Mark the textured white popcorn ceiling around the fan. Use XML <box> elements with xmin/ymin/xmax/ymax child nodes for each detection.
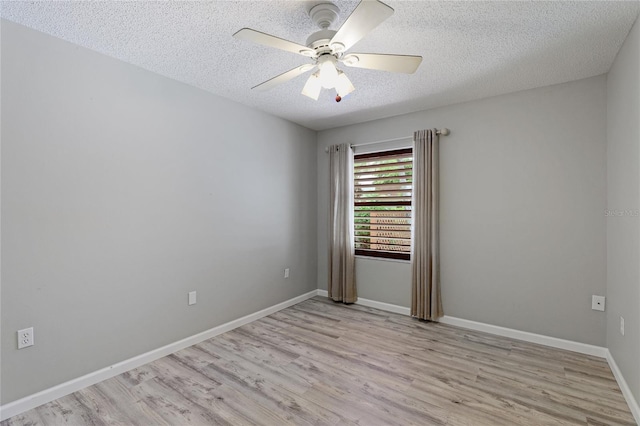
<box><xmin>0</xmin><ymin>0</ymin><xmax>640</xmax><ymax>130</ymax></box>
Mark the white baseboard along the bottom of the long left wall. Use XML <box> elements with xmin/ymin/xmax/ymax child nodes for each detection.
<box><xmin>0</xmin><ymin>290</ymin><xmax>317</xmax><ymax>421</ymax></box>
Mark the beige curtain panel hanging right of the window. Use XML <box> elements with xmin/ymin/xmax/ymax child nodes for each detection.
<box><xmin>411</xmin><ymin>129</ymin><xmax>443</xmax><ymax>321</ymax></box>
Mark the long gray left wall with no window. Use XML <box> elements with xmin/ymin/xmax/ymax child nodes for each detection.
<box><xmin>1</xmin><ymin>21</ymin><xmax>317</xmax><ymax>403</ymax></box>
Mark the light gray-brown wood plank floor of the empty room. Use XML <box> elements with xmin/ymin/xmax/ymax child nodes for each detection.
<box><xmin>1</xmin><ymin>297</ymin><xmax>635</xmax><ymax>426</ymax></box>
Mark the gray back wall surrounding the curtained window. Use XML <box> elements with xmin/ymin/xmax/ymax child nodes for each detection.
<box><xmin>318</xmin><ymin>76</ymin><xmax>606</xmax><ymax>346</ymax></box>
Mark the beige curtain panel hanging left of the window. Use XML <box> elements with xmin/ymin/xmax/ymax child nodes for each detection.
<box><xmin>328</xmin><ymin>144</ymin><xmax>358</xmax><ymax>303</ymax></box>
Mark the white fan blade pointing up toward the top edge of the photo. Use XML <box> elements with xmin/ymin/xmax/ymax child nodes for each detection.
<box><xmin>329</xmin><ymin>0</ymin><xmax>393</xmax><ymax>52</ymax></box>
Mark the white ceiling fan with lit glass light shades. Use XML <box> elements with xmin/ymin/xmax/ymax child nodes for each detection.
<box><xmin>233</xmin><ymin>0</ymin><xmax>422</xmax><ymax>102</ymax></box>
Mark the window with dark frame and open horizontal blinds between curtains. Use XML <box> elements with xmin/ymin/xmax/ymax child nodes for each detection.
<box><xmin>353</xmin><ymin>148</ymin><xmax>413</xmax><ymax>260</ymax></box>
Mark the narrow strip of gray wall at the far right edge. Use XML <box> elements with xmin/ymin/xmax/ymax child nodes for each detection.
<box><xmin>606</xmin><ymin>16</ymin><xmax>640</xmax><ymax>410</ymax></box>
